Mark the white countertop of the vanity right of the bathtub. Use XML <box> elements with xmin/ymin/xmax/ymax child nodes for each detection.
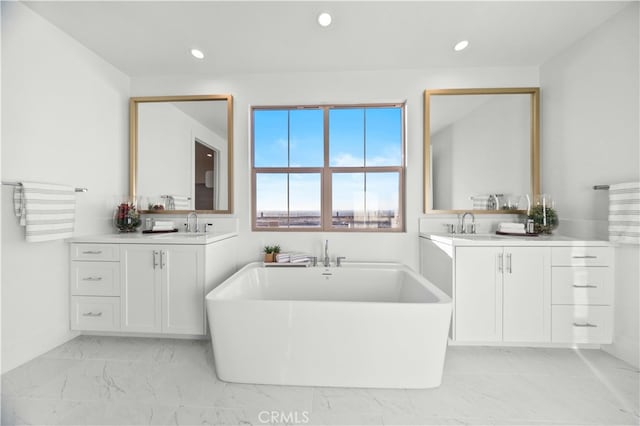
<box><xmin>420</xmin><ymin>232</ymin><xmax>611</xmax><ymax>247</ymax></box>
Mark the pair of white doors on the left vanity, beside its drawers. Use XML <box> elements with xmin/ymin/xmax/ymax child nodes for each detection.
<box><xmin>120</xmin><ymin>244</ymin><xmax>205</xmax><ymax>334</ymax></box>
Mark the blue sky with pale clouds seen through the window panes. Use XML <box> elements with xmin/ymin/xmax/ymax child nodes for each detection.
<box><xmin>253</xmin><ymin>108</ymin><xmax>402</xmax><ymax>212</ymax></box>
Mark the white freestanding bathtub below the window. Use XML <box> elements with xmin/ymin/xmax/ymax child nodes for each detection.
<box><xmin>206</xmin><ymin>262</ymin><xmax>451</xmax><ymax>388</ymax></box>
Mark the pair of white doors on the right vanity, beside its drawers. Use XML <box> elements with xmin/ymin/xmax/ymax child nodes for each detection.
<box><xmin>453</xmin><ymin>246</ymin><xmax>551</xmax><ymax>342</ymax></box>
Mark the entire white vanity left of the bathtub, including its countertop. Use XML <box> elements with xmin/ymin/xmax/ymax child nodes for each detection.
<box><xmin>70</xmin><ymin>233</ymin><xmax>237</xmax><ymax>336</ymax></box>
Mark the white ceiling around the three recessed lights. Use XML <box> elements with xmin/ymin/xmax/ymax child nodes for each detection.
<box><xmin>26</xmin><ymin>0</ymin><xmax>630</xmax><ymax>77</ymax></box>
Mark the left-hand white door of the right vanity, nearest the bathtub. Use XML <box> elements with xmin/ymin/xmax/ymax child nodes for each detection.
<box><xmin>454</xmin><ymin>247</ymin><xmax>502</xmax><ymax>342</ymax></box>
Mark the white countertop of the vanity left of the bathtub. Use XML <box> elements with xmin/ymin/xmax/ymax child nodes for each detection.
<box><xmin>69</xmin><ymin>232</ymin><xmax>238</xmax><ymax>245</ymax></box>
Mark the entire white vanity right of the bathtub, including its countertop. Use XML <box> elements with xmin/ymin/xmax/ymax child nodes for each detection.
<box><xmin>420</xmin><ymin>233</ymin><xmax>614</xmax><ymax>346</ymax></box>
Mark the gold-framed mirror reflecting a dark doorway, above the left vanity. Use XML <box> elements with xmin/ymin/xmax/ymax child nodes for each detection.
<box><xmin>129</xmin><ymin>95</ymin><xmax>233</xmax><ymax>214</ymax></box>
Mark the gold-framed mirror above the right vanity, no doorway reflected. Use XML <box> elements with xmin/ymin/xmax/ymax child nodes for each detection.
<box><xmin>423</xmin><ymin>87</ymin><xmax>540</xmax><ymax>214</ymax></box>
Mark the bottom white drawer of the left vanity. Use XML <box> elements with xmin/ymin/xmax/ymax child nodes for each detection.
<box><xmin>71</xmin><ymin>296</ymin><xmax>120</xmax><ymax>331</ymax></box>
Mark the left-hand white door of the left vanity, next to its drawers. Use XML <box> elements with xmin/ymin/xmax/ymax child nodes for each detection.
<box><xmin>120</xmin><ymin>244</ymin><xmax>162</xmax><ymax>332</ymax></box>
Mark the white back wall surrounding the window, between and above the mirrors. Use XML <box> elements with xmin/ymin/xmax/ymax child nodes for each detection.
<box><xmin>131</xmin><ymin>67</ymin><xmax>539</xmax><ymax>270</ymax></box>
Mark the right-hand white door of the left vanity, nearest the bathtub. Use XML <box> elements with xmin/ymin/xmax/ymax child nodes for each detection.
<box><xmin>161</xmin><ymin>245</ymin><xmax>205</xmax><ymax>334</ymax></box>
